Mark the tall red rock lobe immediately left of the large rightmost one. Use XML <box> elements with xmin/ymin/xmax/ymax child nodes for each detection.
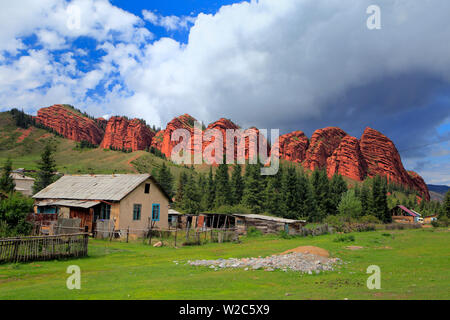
<box><xmin>327</xmin><ymin>136</ymin><xmax>367</xmax><ymax>181</ymax></box>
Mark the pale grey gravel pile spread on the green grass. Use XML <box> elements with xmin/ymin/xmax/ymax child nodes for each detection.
<box><xmin>187</xmin><ymin>253</ymin><xmax>342</xmax><ymax>274</ymax></box>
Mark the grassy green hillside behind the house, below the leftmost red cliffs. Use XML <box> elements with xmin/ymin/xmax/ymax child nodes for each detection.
<box><xmin>0</xmin><ymin>112</ymin><xmax>197</xmax><ymax>177</ymax></box>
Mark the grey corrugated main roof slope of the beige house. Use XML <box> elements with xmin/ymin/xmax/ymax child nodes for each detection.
<box><xmin>33</xmin><ymin>174</ymin><xmax>150</xmax><ymax>201</ymax></box>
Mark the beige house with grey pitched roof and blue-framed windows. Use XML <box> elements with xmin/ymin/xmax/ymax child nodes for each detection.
<box><xmin>33</xmin><ymin>174</ymin><xmax>169</xmax><ymax>235</ymax></box>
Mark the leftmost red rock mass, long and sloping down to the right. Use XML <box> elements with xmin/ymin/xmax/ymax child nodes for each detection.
<box><xmin>35</xmin><ymin>105</ymin><xmax>104</xmax><ymax>145</ymax></box>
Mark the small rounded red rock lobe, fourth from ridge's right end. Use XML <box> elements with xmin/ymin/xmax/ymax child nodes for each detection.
<box><xmin>279</xmin><ymin>131</ymin><xmax>309</xmax><ymax>163</ymax></box>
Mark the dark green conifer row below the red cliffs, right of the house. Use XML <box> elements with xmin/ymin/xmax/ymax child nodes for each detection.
<box><xmin>153</xmin><ymin>164</ymin><xmax>441</xmax><ymax>223</ymax></box>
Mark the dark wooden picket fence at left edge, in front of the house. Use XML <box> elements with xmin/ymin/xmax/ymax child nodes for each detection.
<box><xmin>0</xmin><ymin>233</ymin><xmax>89</xmax><ymax>263</ymax></box>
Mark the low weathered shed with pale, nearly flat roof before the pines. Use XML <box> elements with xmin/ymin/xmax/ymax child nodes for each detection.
<box><xmin>233</xmin><ymin>214</ymin><xmax>306</xmax><ymax>234</ymax></box>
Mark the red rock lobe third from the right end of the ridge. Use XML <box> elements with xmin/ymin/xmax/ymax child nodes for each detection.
<box><xmin>303</xmin><ymin>127</ymin><xmax>347</xmax><ymax>170</ymax></box>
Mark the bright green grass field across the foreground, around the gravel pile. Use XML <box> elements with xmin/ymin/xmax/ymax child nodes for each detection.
<box><xmin>0</xmin><ymin>229</ymin><xmax>450</xmax><ymax>300</ymax></box>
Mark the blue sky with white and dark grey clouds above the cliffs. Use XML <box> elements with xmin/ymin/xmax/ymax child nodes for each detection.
<box><xmin>0</xmin><ymin>0</ymin><xmax>450</xmax><ymax>184</ymax></box>
